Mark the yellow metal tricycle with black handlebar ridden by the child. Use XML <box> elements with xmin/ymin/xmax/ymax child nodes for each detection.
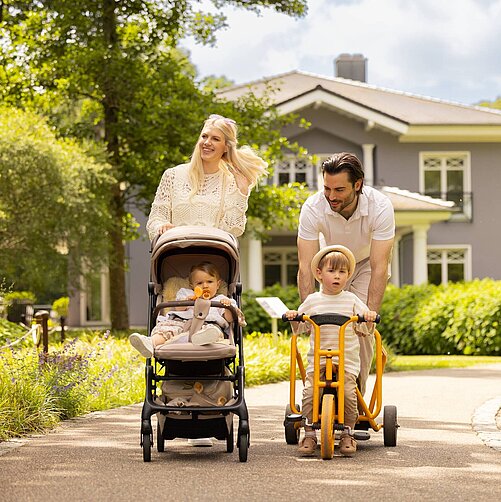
<box><xmin>282</xmin><ymin>314</ymin><xmax>399</xmax><ymax>459</ymax></box>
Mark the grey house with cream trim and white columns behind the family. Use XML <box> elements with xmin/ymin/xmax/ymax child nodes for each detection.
<box><xmin>68</xmin><ymin>55</ymin><xmax>501</xmax><ymax>325</ymax></box>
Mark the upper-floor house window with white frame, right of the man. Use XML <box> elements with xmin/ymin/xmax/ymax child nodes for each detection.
<box><xmin>420</xmin><ymin>152</ymin><xmax>472</xmax><ymax>221</ymax></box>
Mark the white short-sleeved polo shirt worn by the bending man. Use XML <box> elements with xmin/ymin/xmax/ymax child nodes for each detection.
<box><xmin>298</xmin><ymin>186</ymin><xmax>395</xmax><ymax>263</ymax></box>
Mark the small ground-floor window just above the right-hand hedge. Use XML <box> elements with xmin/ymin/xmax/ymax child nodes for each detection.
<box><xmin>428</xmin><ymin>246</ymin><xmax>471</xmax><ymax>285</ymax></box>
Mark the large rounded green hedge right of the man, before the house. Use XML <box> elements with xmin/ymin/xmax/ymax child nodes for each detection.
<box><xmin>380</xmin><ymin>279</ymin><xmax>501</xmax><ymax>355</ymax></box>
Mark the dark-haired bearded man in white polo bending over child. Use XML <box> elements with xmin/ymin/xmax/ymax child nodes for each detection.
<box><xmin>297</xmin><ymin>152</ymin><xmax>395</xmax><ymax>395</ymax></box>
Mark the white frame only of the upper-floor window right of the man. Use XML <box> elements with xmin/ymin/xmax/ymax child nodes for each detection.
<box><xmin>419</xmin><ymin>151</ymin><xmax>472</xmax><ymax>221</ymax></box>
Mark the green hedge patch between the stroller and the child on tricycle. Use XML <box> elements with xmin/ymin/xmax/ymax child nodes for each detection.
<box><xmin>242</xmin><ymin>284</ymin><xmax>301</xmax><ymax>334</ymax></box>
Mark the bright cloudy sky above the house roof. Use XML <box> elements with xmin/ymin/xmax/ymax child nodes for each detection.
<box><xmin>182</xmin><ymin>0</ymin><xmax>501</xmax><ymax>104</ymax></box>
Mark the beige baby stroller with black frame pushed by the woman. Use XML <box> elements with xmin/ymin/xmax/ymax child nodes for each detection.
<box><xmin>141</xmin><ymin>226</ymin><xmax>250</xmax><ymax>462</ymax></box>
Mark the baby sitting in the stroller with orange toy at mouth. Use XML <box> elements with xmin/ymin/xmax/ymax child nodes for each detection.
<box><xmin>129</xmin><ymin>261</ymin><xmax>244</xmax><ymax>357</ymax></box>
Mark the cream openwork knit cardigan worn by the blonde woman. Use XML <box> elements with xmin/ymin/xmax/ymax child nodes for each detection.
<box><xmin>146</xmin><ymin>164</ymin><xmax>249</xmax><ymax>240</ymax></box>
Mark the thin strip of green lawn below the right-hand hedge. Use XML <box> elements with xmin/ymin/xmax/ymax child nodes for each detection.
<box><xmin>389</xmin><ymin>355</ymin><xmax>501</xmax><ymax>371</ymax></box>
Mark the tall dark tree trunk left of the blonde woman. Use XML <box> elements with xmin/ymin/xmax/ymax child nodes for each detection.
<box><xmin>103</xmin><ymin>0</ymin><xmax>129</xmax><ymax>330</ymax></box>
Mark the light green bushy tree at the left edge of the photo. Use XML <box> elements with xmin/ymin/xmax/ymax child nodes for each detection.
<box><xmin>0</xmin><ymin>107</ymin><xmax>114</xmax><ymax>301</ymax></box>
